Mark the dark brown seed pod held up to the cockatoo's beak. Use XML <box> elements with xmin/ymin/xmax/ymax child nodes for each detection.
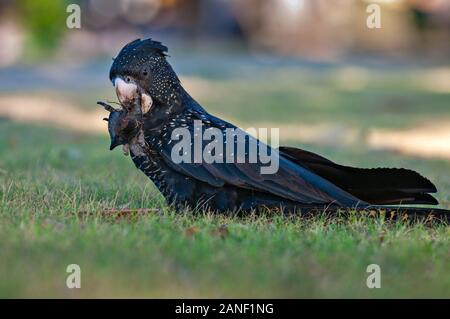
<box><xmin>97</xmin><ymin>102</ymin><xmax>141</xmax><ymax>150</ymax></box>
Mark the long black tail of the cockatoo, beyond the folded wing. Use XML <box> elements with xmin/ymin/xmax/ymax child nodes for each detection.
<box><xmin>279</xmin><ymin>146</ymin><xmax>438</xmax><ymax>206</ymax></box>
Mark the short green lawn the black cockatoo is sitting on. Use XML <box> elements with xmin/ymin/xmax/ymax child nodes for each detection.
<box><xmin>0</xmin><ymin>66</ymin><xmax>450</xmax><ymax>298</ymax></box>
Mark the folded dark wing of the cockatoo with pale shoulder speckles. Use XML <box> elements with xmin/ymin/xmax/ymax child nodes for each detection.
<box><xmin>147</xmin><ymin>109</ymin><xmax>365</xmax><ymax>206</ymax></box>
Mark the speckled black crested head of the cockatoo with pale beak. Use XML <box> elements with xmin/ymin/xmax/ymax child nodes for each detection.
<box><xmin>109</xmin><ymin>39</ymin><xmax>181</xmax><ymax>114</ymax></box>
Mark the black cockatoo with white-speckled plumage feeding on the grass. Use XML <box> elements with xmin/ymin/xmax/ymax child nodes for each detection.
<box><xmin>103</xmin><ymin>39</ymin><xmax>448</xmax><ymax>220</ymax></box>
